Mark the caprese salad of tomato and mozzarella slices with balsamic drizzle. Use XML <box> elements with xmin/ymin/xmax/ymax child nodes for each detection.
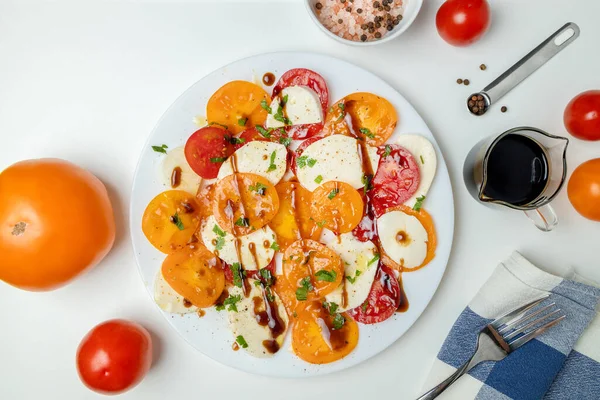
<box><xmin>142</xmin><ymin>69</ymin><xmax>436</xmax><ymax>364</ymax></box>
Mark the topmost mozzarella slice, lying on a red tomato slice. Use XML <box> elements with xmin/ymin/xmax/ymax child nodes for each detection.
<box><xmin>266</xmin><ymin>86</ymin><xmax>323</xmax><ymax>128</ymax></box>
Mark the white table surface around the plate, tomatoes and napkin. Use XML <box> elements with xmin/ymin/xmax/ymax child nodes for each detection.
<box><xmin>0</xmin><ymin>0</ymin><xmax>600</xmax><ymax>400</ymax></box>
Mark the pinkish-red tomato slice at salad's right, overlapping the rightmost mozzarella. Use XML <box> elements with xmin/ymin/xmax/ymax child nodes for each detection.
<box><xmin>369</xmin><ymin>144</ymin><xmax>420</xmax><ymax>217</ymax></box>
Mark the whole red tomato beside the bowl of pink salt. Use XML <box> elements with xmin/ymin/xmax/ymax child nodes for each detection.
<box><xmin>435</xmin><ymin>0</ymin><xmax>490</xmax><ymax>46</ymax></box>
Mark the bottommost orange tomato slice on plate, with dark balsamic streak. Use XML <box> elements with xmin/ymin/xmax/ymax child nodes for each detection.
<box><xmin>292</xmin><ymin>302</ymin><xmax>359</xmax><ymax>364</ymax></box>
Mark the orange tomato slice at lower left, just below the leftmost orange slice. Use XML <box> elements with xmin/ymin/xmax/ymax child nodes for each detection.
<box><xmin>161</xmin><ymin>244</ymin><xmax>225</xmax><ymax>308</ymax></box>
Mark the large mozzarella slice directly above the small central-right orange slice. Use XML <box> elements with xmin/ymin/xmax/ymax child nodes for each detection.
<box><xmin>296</xmin><ymin>135</ymin><xmax>364</xmax><ymax>192</ymax></box>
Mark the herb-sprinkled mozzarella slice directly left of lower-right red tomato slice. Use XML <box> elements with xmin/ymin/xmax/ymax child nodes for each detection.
<box><xmin>325</xmin><ymin>232</ymin><xmax>378</xmax><ymax>311</ymax></box>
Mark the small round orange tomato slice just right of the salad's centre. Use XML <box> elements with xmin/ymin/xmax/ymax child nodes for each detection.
<box><xmin>311</xmin><ymin>181</ymin><xmax>364</xmax><ymax>235</ymax></box>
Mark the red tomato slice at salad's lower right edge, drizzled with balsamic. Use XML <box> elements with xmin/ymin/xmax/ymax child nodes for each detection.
<box><xmin>348</xmin><ymin>263</ymin><xmax>401</xmax><ymax>324</ymax></box>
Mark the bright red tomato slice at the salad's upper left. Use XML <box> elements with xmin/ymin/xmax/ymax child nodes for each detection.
<box><xmin>185</xmin><ymin>126</ymin><xmax>235</xmax><ymax>179</ymax></box>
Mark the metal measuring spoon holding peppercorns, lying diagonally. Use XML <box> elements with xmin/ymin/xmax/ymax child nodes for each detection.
<box><xmin>467</xmin><ymin>22</ymin><xmax>580</xmax><ymax>115</ymax></box>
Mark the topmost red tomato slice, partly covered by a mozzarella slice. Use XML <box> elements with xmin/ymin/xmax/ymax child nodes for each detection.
<box><xmin>272</xmin><ymin>68</ymin><xmax>329</xmax><ymax>140</ymax></box>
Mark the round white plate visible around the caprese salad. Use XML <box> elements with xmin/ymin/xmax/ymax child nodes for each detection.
<box><xmin>130</xmin><ymin>52</ymin><xmax>454</xmax><ymax>377</ymax></box>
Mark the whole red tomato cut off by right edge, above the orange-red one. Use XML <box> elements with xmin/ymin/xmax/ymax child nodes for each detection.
<box><xmin>564</xmin><ymin>90</ymin><xmax>600</xmax><ymax>140</ymax></box>
